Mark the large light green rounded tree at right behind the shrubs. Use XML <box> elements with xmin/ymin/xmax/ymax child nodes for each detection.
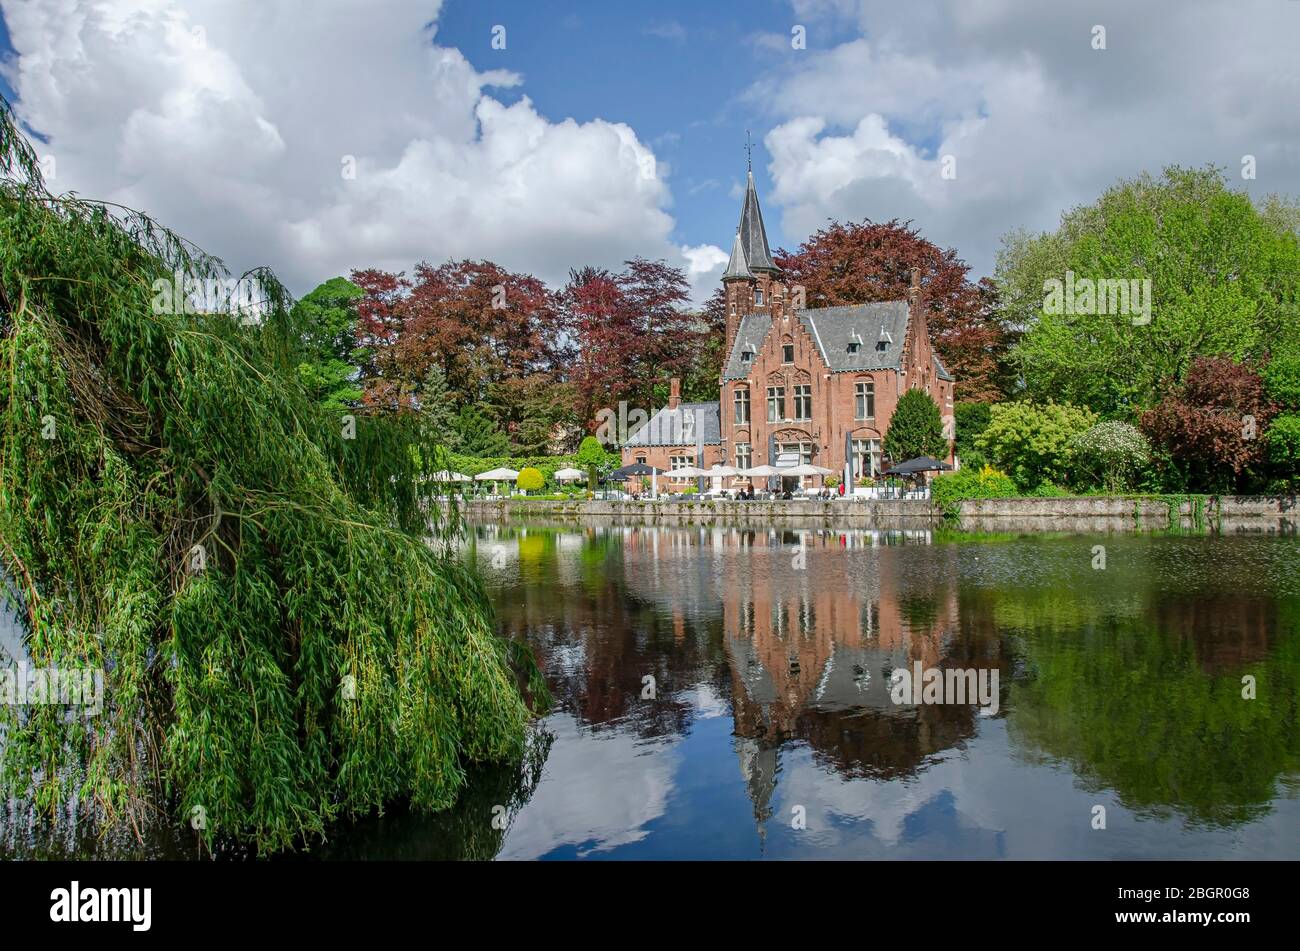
<box><xmin>996</xmin><ymin>168</ymin><xmax>1300</xmax><ymax>416</ymax></box>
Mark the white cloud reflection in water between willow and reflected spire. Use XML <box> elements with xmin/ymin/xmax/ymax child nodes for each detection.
<box><xmin>498</xmin><ymin>713</ymin><xmax>680</xmax><ymax>859</ymax></box>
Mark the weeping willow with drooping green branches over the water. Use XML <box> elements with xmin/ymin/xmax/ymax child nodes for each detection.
<box><xmin>0</xmin><ymin>99</ymin><xmax>536</xmax><ymax>854</ymax></box>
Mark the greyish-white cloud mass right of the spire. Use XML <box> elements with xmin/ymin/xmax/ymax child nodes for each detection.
<box><xmin>748</xmin><ymin>0</ymin><xmax>1300</xmax><ymax>273</ymax></box>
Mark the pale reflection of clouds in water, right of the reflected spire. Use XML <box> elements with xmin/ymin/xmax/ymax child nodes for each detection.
<box><xmin>767</xmin><ymin>720</ymin><xmax>1300</xmax><ymax>859</ymax></box>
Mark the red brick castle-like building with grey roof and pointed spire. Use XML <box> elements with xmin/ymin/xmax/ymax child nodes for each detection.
<box><xmin>623</xmin><ymin>164</ymin><xmax>953</xmax><ymax>487</ymax></box>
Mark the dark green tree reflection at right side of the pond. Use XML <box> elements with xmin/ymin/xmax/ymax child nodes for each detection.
<box><xmin>979</xmin><ymin>579</ymin><xmax>1300</xmax><ymax>825</ymax></box>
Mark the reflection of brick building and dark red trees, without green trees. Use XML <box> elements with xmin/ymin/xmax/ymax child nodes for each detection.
<box><xmin>483</xmin><ymin>526</ymin><xmax>1006</xmax><ymax>828</ymax></box>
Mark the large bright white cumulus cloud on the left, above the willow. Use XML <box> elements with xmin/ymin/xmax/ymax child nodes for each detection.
<box><xmin>0</xmin><ymin>0</ymin><xmax>720</xmax><ymax>292</ymax></box>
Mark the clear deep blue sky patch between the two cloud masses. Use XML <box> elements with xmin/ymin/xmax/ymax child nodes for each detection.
<box><xmin>428</xmin><ymin>0</ymin><xmax>853</xmax><ymax>255</ymax></box>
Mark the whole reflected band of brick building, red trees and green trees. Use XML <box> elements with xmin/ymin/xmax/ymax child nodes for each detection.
<box><xmin>480</xmin><ymin>527</ymin><xmax>1300</xmax><ymax>841</ymax></box>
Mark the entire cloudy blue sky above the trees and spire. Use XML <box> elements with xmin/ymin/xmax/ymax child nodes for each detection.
<box><xmin>0</xmin><ymin>0</ymin><xmax>1300</xmax><ymax>300</ymax></box>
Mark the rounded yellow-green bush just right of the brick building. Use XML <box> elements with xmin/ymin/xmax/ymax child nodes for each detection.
<box><xmin>975</xmin><ymin>403</ymin><xmax>1097</xmax><ymax>491</ymax></box>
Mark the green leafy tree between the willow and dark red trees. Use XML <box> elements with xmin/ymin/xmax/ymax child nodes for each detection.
<box><xmin>291</xmin><ymin>277</ymin><xmax>365</xmax><ymax>409</ymax></box>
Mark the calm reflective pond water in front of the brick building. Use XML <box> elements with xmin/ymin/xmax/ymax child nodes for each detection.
<box><xmin>0</xmin><ymin>525</ymin><xmax>1300</xmax><ymax>859</ymax></box>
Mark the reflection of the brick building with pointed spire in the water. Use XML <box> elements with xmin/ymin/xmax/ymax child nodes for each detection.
<box><xmin>719</xmin><ymin>531</ymin><xmax>1002</xmax><ymax>828</ymax></box>
